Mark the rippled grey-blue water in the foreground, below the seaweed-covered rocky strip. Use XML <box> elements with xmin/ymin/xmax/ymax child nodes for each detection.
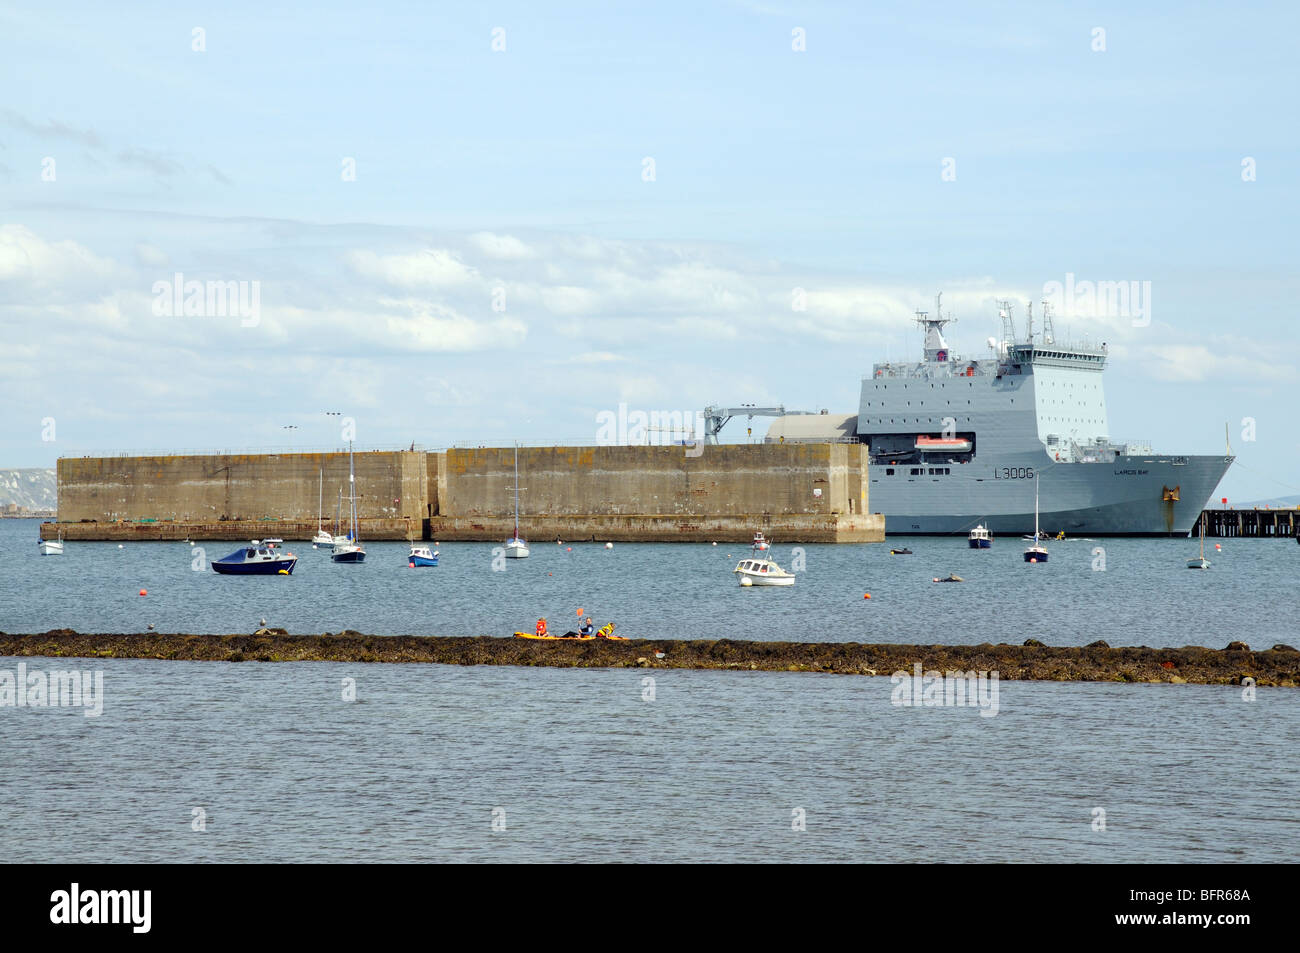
<box><xmin>0</xmin><ymin>658</ymin><xmax>1300</xmax><ymax>862</ymax></box>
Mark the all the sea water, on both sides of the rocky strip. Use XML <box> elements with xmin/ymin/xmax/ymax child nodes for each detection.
<box><xmin>0</xmin><ymin>520</ymin><xmax>1300</xmax><ymax>862</ymax></box>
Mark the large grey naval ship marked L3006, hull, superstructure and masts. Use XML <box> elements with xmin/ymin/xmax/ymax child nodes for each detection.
<box><xmin>857</xmin><ymin>302</ymin><xmax>1234</xmax><ymax>536</ymax></box>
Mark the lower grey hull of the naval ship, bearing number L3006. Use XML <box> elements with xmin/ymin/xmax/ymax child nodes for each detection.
<box><xmin>868</xmin><ymin>454</ymin><xmax>1232</xmax><ymax>537</ymax></box>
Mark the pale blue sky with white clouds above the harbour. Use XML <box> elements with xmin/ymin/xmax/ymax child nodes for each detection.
<box><xmin>0</xmin><ymin>1</ymin><xmax>1300</xmax><ymax>499</ymax></box>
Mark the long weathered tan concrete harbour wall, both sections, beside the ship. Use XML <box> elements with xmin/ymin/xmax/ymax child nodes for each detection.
<box><xmin>42</xmin><ymin>443</ymin><xmax>884</xmax><ymax>542</ymax></box>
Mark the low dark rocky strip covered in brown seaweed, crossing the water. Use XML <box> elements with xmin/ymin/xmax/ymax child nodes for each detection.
<box><xmin>0</xmin><ymin>629</ymin><xmax>1300</xmax><ymax>688</ymax></box>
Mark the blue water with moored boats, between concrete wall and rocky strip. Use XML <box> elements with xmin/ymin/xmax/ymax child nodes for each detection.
<box><xmin>0</xmin><ymin>520</ymin><xmax>1300</xmax><ymax>647</ymax></box>
